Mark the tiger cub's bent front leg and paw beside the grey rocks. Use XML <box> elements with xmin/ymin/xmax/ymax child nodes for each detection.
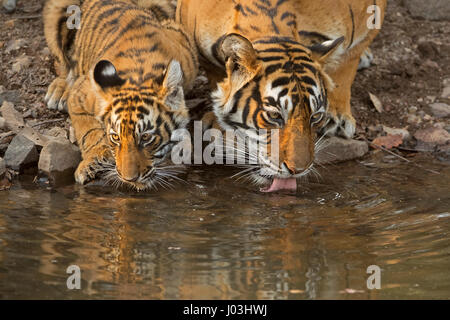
<box><xmin>68</xmin><ymin>79</ymin><xmax>114</xmax><ymax>185</ymax></box>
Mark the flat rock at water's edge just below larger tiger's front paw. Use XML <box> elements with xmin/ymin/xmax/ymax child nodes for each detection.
<box><xmin>317</xmin><ymin>137</ymin><xmax>369</xmax><ymax>163</ymax></box>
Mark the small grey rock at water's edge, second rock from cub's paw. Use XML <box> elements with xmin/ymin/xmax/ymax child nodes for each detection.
<box><xmin>4</xmin><ymin>134</ymin><xmax>39</xmax><ymax>171</ymax></box>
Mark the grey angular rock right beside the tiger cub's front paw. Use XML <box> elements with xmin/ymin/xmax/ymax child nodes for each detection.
<box><xmin>38</xmin><ymin>140</ymin><xmax>81</xmax><ymax>183</ymax></box>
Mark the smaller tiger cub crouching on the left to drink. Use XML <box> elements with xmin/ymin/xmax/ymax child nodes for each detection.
<box><xmin>44</xmin><ymin>0</ymin><xmax>198</xmax><ymax>190</ymax></box>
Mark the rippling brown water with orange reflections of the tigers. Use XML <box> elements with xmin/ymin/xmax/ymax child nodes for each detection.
<box><xmin>0</xmin><ymin>154</ymin><xmax>450</xmax><ymax>299</ymax></box>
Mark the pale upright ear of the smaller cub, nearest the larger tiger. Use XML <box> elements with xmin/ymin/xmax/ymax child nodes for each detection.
<box><xmin>163</xmin><ymin>60</ymin><xmax>186</xmax><ymax>110</ymax></box>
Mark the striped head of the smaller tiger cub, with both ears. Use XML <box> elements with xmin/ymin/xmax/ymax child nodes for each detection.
<box><xmin>92</xmin><ymin>60</ymin><xmax>189</xmax><ymax>190</ymax></box>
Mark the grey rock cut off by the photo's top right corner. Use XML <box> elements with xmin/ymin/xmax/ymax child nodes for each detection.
<box><xmin>404</xmin><ymin>0</ymin><xmax>450</xmax><ymax>20</ymax></box>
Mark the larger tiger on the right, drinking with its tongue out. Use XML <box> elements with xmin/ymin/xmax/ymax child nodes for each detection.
<box><xmin>177</xmin><ymin>0</ymin><xmax>386</xmax><ymax>191</ymax></box>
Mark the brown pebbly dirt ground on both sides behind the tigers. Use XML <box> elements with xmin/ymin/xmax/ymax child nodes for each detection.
<box><xmin>0</xmin><ymin>0</ymin><xmax>450</xmax><ymax>157</ymax></box>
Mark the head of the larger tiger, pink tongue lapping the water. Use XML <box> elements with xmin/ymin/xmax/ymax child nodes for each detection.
<box><xmin>213</xmin><ymin>34</ymin><xmax>344</xmax><ymax>192</ymax></box>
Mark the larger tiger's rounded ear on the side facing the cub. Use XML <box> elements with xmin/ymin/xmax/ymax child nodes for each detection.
<box><xmin>218</xmin><ymin>33</ymin><xmax>261</xmax><ymax>93</ymax></box>
